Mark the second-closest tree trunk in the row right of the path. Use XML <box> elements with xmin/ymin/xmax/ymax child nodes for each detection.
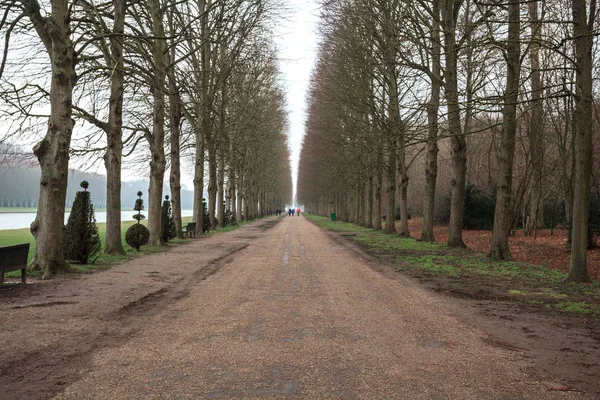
<box><xmin>490</xmin><ymin>0</ymin><xmax>521</xmax><ymax>260</ymax></box>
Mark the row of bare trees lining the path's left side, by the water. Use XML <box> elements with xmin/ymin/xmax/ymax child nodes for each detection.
<box><xmin>0</xmin><ymin>0</ymin><xmax>291</xmax><ymax>277</ymax></box>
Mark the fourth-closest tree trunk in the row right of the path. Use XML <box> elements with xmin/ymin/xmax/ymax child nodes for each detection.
<box><xmin>421</xmin><ymin>0</ymin><xmax>442</xmax><ymax>242</ymax></box>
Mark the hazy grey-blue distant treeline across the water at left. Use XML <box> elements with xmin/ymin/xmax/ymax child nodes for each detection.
<box><xmin>0</xmin><ymin>165</ymin><xmax>193</xmax><ymax>209</ymax></box>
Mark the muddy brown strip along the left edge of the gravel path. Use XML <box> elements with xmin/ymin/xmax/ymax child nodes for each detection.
<box><xmin>0</xmin><ymin>219</ymin><xmax>277</xmax><ymax>400</ymax></box>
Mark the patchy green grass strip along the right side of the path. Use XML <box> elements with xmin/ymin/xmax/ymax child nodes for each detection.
<box><xmin>305</xmin><ymin>214</ymin><xmax>600</xmax><ymax>317</ymax></box>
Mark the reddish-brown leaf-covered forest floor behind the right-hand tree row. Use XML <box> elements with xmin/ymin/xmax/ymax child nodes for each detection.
<box><xmin>408</xmin><ymin>218</ymin><xmax>600</xmax><ymax>281</ymax></box>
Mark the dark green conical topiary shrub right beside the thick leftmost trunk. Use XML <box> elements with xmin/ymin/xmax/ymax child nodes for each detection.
<box><xmin>63</xmin><ymin>181</ymin><xmax>102</xmax><ymax>264</ymax></box>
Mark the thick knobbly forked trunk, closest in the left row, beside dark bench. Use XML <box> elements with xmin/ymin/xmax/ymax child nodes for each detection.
<box><xmin>24</xmin><ymin>0</ymin><xmax>77</xmax><ymax>279</ymax></box>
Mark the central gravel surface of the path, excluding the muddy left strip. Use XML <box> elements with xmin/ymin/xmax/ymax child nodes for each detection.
<box><xmin>49</xmin><ymin>217</ymin><xmax>583</xmax><ymax>400</ymax></box>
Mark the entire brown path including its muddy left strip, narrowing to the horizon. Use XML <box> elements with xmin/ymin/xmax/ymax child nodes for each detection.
<box><xmin>0</xmin><ymin>217</ymin><xmax>598</xmax><ymax>399</ymax></box>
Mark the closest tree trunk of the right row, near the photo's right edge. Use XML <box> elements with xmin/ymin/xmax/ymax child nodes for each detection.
<box><xmin>568</xmin><ymin>0</ymin><xmax>596</xmax><ymax>282</ymax></box>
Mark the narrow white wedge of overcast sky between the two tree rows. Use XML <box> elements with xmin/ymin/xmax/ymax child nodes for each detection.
<box><xmin>275</xmin><ymin>0</ymin><xmax>319</xmax><ymax>200</ymax></box>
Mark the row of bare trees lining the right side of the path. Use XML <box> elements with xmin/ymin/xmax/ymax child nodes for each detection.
<box><xmin>298</xmin><ymin>0</ymin><xmax>598</xmax><ymax>281</ymax></box>
